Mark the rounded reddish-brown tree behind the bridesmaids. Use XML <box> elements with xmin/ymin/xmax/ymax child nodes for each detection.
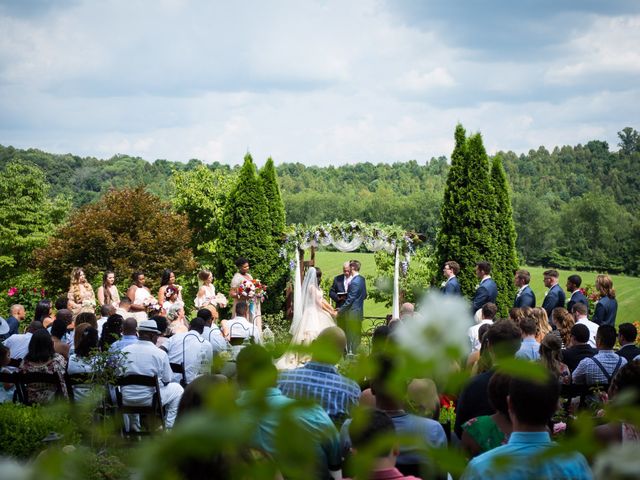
<box><xmin>35</xmin><ymin>187</ymin><xmax>196</xmax><ymax>291</ymax></box>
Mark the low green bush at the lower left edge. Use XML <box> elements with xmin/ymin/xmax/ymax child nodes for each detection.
<box><xmin>0</xmin><ymin>403</ymin><xmax>79</xmax><ymax>459</ymax></box>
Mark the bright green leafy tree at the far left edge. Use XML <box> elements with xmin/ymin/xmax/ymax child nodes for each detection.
<box><xmin>0</xmin><ymin>161</ymin><xmax>69</xmax><ymax>283</ymax></box>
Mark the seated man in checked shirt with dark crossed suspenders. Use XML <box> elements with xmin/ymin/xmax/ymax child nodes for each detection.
<box><xmin>572</xmin><ymin>324</ymin><xmax>627</xmax><ymax>385</ymax></box>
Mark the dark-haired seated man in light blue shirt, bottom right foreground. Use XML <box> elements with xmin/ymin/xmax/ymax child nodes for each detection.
<box><xmin>462</xmin><ymin>375</ymin><xmax>592</xmax><ymax>480</ymax></box>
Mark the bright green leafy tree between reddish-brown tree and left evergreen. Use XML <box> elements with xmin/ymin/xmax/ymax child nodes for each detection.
<box><xmin>172</xmin><ymin>165</ymin><xmax>234</xmax><ymax>266</ymax></box>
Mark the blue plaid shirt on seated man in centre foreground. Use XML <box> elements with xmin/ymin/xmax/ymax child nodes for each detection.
<box><xmin>278</xmin><ymin>362</ymin><xmax>360</xmax><ymax>422</ymax></box>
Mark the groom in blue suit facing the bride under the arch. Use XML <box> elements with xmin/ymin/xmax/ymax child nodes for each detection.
<box><xmin>338</xmin><ymin>260</ymin><xmax>367</xmax><ymax>354</ymax></box>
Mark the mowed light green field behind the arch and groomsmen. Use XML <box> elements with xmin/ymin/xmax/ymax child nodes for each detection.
<box><xmin>307</xmin><ymin>251</ymin><xmax>640</xmax><ymax>324</ymax></box>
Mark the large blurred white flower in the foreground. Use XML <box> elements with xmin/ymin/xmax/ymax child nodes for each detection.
<box><xmin>395</xmin><ymin>292</ymin><xmax>473</xmax><ymax>360</ymax></box>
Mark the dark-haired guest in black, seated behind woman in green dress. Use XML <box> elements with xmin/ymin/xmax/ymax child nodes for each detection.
<box><xmin>454</xmin><ymin>320</ymin><xmax>520</xmax><ymax>438</ymax></box>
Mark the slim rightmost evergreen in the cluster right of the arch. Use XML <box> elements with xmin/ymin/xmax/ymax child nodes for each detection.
<box><xmin>491</xmin><ymin>155</ymin><xmax>518</xmax><ymax>317</ymax></box>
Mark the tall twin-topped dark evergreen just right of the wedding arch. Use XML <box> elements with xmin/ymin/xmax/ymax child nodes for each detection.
<box><xmin>436</xmin><ymin>125</ymin><xmax>495</xmax><ymax>297</ymax></box>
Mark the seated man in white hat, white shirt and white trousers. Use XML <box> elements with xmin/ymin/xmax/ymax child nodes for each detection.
<box><xmin>122</xmin><ymin>320</ymin><xmax>184</xmax><ymax>428</ymax></box>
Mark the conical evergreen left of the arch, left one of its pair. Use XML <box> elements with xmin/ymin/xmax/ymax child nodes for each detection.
<box><xmin>216</xmin><ymin>154</ymin><xmax>283</xmax><ymax>313</ymax></box>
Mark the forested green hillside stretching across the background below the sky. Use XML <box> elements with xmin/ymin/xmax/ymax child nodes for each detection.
<box><xmin>0</xmin><ymin>128</ymin><xmax>640</xmax><ymax>273</ymax></box>
